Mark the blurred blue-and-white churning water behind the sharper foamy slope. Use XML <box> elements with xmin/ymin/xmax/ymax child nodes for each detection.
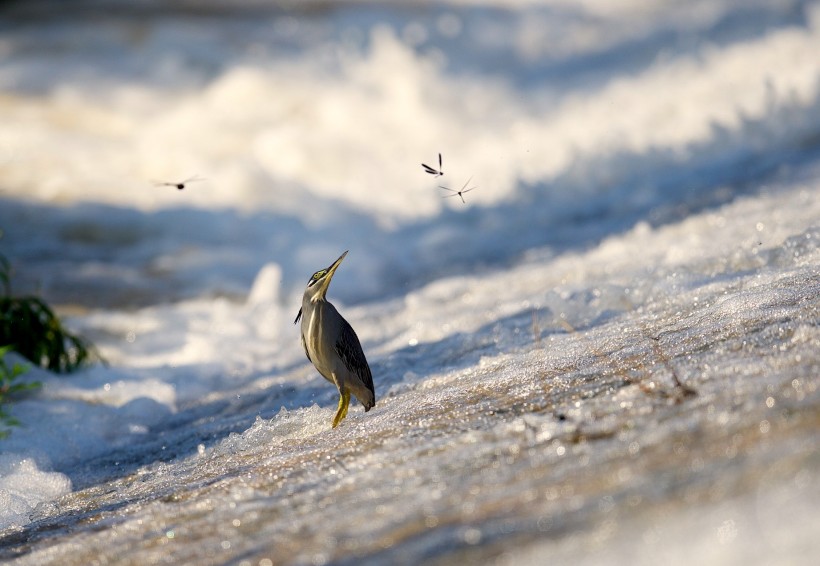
<box><xmin>0</xmin><ymin>0</ymin><xmax>820</xmax><ymax>308</ymax></box>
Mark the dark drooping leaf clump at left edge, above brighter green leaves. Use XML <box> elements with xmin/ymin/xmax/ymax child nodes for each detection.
<box><xmin>0</xmin><ymin>251</ymin><xmax>95</xmax><ymax>373</ymax></box>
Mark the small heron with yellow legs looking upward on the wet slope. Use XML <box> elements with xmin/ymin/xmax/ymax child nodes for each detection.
<box><xmin>293</xmin><ymin>250</ymin><xmax>376</xmax><ymax>428</ymax></box>
